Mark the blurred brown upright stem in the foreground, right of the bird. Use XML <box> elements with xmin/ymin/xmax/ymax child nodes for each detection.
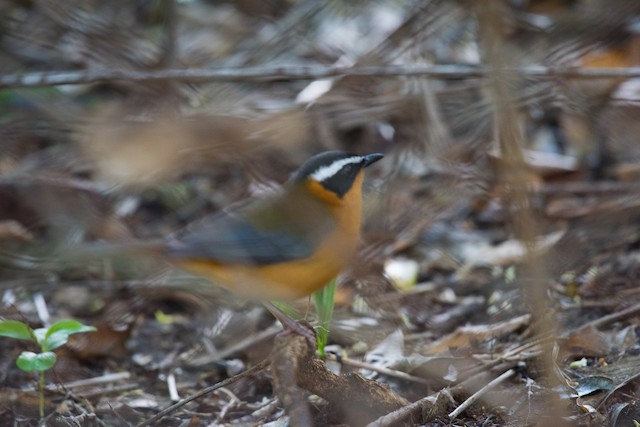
<box><xmin>476</xmin><ymin>0</ymin><xmax>565</xmax><ymax>420</ymax></box>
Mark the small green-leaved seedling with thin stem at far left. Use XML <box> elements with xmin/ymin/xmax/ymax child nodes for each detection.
<box><xmin>0</xmin><ymin>320</ymin><xmax>96</xmax><ymax>418</ymax></box>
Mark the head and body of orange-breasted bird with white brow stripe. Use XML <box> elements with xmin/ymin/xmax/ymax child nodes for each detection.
<box><xmin>160</xmin><ymin>151</ymin><xmax>384</xmax><ymax>301</ymax></box>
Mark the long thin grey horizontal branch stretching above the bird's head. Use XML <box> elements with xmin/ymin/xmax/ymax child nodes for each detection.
<box><xmin>0</xmin><ymin>65</ymin><xmax>640</xmax><ymax>89</ymax></box>
